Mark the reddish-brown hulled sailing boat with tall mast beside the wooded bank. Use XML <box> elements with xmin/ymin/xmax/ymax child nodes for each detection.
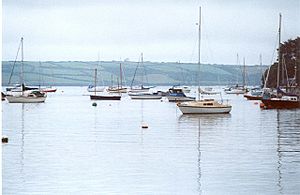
<box><xmin>261</xmin><ymin>13</ymin><xmax>300</xmax><ymax>109</ymax></box>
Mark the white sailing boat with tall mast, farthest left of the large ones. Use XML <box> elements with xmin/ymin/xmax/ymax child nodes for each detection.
<box><xmin>6</xmin><ymin>37</ymin><xmax>47</xmax><ymax>103</ymax></box>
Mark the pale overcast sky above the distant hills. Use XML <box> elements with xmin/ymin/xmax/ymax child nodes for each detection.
<box><xmin>2</xmin><ymin>0</ymin><xmax>300</xmax><ymax>64</ymax></box>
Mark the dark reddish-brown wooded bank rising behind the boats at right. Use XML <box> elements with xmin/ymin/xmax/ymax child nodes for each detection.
<box><xmin>264</xmin><ymin>37</ymin><xmax>300</xmax><ymax>88</ymax></box>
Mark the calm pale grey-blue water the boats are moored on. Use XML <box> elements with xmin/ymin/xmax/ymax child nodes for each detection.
<box><xmin>2</xmin><ymin>87</ymin><xmax>300</xmax><ymax>195</ymax></box>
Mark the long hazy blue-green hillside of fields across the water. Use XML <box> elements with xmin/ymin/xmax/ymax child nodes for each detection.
<box><xmin>2</xmin><ymin>61</ymin><xmax>267</xmax><ymax>86</ymax></box>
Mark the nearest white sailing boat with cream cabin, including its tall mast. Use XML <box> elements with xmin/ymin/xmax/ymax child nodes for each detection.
<box><xmin>177</xmin><ymin>7</ymin><xmax>231</xmax><ymax>114</ymax></box>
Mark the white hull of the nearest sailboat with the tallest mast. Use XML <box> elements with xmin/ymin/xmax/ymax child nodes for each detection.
<box><xmin>178</xmin><ymin>106</ymin><xmax>231</xmax><ymax>114</ymax></box>
